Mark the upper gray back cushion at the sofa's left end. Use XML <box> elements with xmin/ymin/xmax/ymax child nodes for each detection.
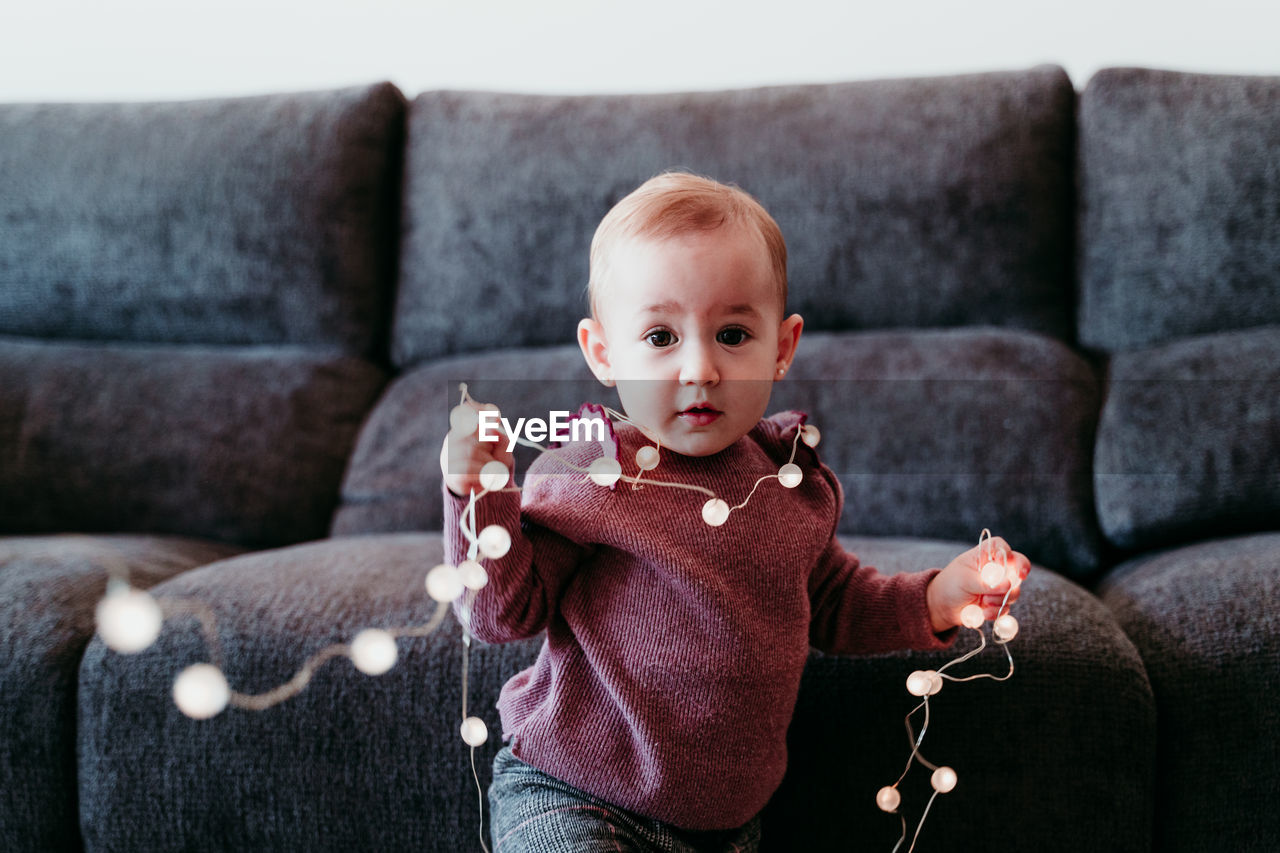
<box><xmin>0</xmin><ymin>83</ymin><xmax>404</xmax><ymax>353</ymax></box>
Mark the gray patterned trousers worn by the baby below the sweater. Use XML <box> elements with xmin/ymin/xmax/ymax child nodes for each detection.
<box><xmin>489</xmin><ymin>747</ymin><xmax>760</xmax><ymax>853</ymax></box>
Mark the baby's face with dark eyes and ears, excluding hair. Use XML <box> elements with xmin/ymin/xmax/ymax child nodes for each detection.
<box><xmin>579</xmin><ymin>227</ymin><xmax>801</xmax><ymax>456</ymax></box>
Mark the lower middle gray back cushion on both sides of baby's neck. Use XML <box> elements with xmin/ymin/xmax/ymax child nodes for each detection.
<box><xmin>333</xmin><ymin>328</ymin><xmax>1102</xmax><ymax>576</ymax></box>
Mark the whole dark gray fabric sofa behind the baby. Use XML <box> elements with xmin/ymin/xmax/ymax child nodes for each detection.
<box><xmin>0</xmin><ymin>67</ymin><xmax>1280</xmax><ymax>852</ymax></box>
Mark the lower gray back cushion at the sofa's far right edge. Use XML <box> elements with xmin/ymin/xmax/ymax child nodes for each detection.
<box><xmin>1094</xmin><ymin>327</ymin><xmax>1280</xmax><ymax>548</ymax></box>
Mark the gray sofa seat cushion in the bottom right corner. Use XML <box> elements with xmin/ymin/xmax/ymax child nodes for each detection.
<box><xmin>1098</xmin><ymin>533</ymin><xmax>1280</xmax><ymax>853</ymax></box>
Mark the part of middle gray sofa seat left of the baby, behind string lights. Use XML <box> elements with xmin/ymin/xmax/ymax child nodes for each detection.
<box><xmin>79</xmin><ymin>534</ymin><xmax>538</xmax><ymax>853</ymax></box>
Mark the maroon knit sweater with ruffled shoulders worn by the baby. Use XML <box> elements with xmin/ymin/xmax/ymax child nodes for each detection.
<box><xmin>444</xmin><ymin>412</ymin><xmax>955</xmax><ymax>830</ymax></box>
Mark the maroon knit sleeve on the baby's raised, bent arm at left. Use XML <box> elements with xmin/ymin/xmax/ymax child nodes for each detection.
<box><xmin>442</xmin><ymin>448</ymin><xmax>594</xmax><ymax>643</ymax></box>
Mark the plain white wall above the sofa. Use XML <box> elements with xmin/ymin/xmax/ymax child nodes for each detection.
<box><xmin>0</xmin><ymin>0</ymin><xmax>1280</xmax><ymax>101</ymax></box>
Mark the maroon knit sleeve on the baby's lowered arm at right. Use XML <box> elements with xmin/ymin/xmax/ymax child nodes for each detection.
<box><xmin>809</xmin><ymin>465</ymin><xmax>956</xmax><ymax>654</ymax></box>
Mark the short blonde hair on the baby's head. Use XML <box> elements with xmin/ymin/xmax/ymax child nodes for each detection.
<box><xmin>588</xmin><ymin>172</ymin><xmax>787</xmax><ymax>318</ymax></box>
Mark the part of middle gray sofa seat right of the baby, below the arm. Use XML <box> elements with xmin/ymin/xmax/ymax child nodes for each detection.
<box><xmin>764</xmin><ymin>535</ymin><xmax>1156</xmax><ymax>852</ymax></box>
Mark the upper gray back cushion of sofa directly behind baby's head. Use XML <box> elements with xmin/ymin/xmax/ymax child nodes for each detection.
<box><xmin>392</xmin><ymin>65</ymin><xmax>1075</xmax><ymax>366</ymax></box>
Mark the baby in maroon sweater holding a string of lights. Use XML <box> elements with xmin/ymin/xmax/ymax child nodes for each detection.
<box><xmin>440</xmin><ymin>173</ymin><xmax>1030</xmax><ymax>853</ymax></box>
